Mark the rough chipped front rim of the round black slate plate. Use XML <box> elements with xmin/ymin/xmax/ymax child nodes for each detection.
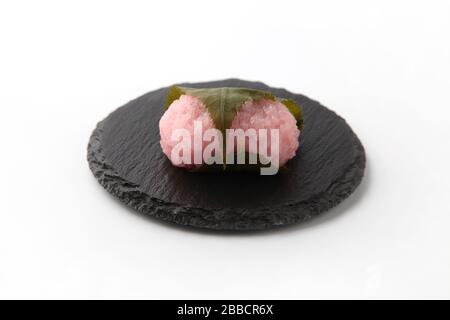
<box><xmin>87</xmin><ymin>80</ymin><xmax>366</xmax><ymax>231</ymax></box>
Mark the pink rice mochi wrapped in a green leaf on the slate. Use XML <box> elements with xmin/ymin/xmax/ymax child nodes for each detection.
<box><xmin>159</xmin><ymin>87</ymin><xmax>303</xmax><ymax>174</ymax></box>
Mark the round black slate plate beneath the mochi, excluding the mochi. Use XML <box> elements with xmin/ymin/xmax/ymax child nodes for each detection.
<box><xmin>87</xmin><ymin>79</ymin><xmax>365</xmax><ymax>230</ymax></box>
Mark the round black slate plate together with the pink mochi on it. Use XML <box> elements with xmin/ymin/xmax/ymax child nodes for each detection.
<box><xmin>87</xmin><ymin>79</ymin><xmax>366</xmax><ymax>231</ymax></box>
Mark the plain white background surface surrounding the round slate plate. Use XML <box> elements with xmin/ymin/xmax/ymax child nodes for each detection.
<box><xmin>0</xmin><ymin>0</ymin><xmax>450</xmax><ymax>299</ymax></box>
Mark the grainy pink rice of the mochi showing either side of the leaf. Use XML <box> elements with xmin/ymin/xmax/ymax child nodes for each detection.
<box><xmin>159</xmin><ymin>95</ymin><xmax>300</xmax><ymax>168</ymax></box>
